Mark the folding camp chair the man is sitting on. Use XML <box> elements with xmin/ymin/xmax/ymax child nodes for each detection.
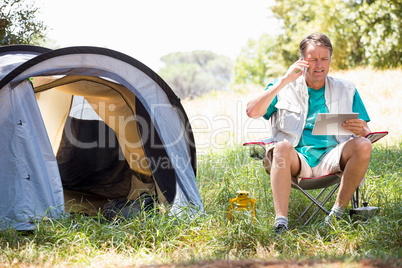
<box><xmin>243</xmin><ymin>131</ymin><xmax>388</xmax><ymax>225</ymax></box>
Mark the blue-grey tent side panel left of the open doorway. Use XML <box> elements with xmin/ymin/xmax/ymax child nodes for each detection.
<box><xmin>0</xmin><ymin>78</ymin><xmax>64</xmax><ymax>229</ymax></box>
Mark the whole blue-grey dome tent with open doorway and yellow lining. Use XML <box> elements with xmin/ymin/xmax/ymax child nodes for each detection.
<box><xmin>0</xmin><ymin>46</ymin><xmax>203</xmax><ymax>229</ymax></box>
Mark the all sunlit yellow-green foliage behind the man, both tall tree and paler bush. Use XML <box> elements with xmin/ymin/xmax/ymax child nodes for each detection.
<box><xmin>235</xmin><ymin>0</ymin><xmax>402</xmax><ymax>85</ymax></box>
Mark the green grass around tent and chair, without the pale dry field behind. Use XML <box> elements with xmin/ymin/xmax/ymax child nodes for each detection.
<box><xmin>0</xmin><ymin>141</ymin><xmax>402</xmax><ymax>267</ymax></box>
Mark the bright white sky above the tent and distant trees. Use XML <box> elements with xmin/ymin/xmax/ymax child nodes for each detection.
<box><xmin>35</xmin><ymin>0</ymin><xmax>279</xmax><ymax>71</ymax></box>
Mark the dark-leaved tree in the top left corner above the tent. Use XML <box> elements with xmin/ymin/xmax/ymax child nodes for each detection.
<box><xmin>0</xmin><ymin>0</ymin><xmax>47</xmax><ymax>45</ymax></box>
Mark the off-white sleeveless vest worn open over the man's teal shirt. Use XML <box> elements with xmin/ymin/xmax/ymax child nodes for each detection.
<box><xmin>271</xmin><ymin>76</ymin><xmax>356</xmax><ymax>146</ymax></box>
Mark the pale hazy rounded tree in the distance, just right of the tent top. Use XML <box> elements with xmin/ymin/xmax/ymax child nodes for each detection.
<box><xmin>158</xmin><ymin>51</ymin><xmax>233</xmax><ymax>98</ymax></box>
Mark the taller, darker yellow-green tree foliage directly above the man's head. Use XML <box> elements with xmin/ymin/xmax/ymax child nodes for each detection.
<box><xmin>272</xmin><ymin>0</ymin><xmax>402</xmax><ymax>69</ymax></box>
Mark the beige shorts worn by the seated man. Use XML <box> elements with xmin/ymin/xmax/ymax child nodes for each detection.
<box><xmin>263</xmin><ymin>142</ymin><xmax>347</xmax><ymax>182</ymax></box>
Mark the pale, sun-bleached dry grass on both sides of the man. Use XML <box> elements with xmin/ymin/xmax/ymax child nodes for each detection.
<box><xmin>183</xmin><ymin>69</ymin><xmax>402</xmax><ymax>154</ymax></box>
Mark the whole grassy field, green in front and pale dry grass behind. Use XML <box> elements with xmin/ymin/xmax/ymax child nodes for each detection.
<box><xmin>0</xmin><ymin>70</ymin><xmax>402</xmax><ymax>267</ymax></box>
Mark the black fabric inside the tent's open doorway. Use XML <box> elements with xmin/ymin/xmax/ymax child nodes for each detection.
<box><xmin>56</xmin><ymin>117</ymin><xmax>133</xmax><ymax>198</ymax></box>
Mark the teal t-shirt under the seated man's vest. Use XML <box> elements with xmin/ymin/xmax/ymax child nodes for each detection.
<box><xmin>264</xmin><ymin>80</ymin><xmax>370</xmax><ymax>167</ymax></box>
